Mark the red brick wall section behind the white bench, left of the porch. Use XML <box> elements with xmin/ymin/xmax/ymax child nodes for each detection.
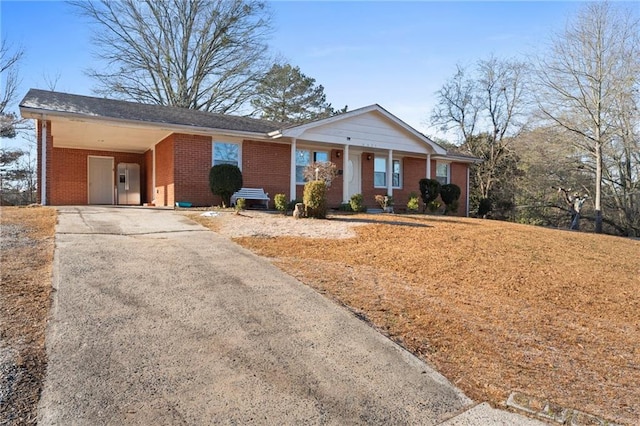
<box><xmin>242</xmin><ymin>140</ymin><xmax>291</xmax><ymax>208</ymax></box>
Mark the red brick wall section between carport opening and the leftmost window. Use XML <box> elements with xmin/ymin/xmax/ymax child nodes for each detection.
<box><xmin>172</xmin><ymin>133</ymin><xmax>214</xmax><ymax>206</ymax></box>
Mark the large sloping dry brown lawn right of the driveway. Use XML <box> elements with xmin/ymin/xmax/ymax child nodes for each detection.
<box><xmin>203</xmin><ymin>215</ymin><xmax>640</xmax><ymax>424</ymax></box>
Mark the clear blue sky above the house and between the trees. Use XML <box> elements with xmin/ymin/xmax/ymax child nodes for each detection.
<box><xmin>0</xmin><ymin>0</ymin><xmax>596</xmax><ymax>146</ymax></box>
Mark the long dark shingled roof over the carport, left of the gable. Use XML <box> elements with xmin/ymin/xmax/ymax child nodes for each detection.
<box><xmin>20</xmin><ymin>89</ymin><xmax>282</xmax><ymax>134</ymax></box>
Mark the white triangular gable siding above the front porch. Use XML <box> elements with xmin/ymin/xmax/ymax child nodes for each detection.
<box><xmin>298</xmin><ymin>112</ymin><xmax>433</xmax><ymax>154</ymax></box>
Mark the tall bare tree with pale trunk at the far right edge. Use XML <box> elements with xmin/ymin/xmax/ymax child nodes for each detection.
<box><xmin>536</xmin><ymin>2</ymin><xmax>640</xmax><ymax>232</ymax></box>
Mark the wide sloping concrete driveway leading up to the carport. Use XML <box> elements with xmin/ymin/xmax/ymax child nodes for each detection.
<box><xmin>39</xmin><ymin>207</ymin><xmax>537</xmax><ymax>425</ymax></box>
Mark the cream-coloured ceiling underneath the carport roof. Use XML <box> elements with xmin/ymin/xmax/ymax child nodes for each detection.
<box><xmin>49</xmin><ymin>116</ymin><xmax>174</xmax><ymax>153</ymax></box>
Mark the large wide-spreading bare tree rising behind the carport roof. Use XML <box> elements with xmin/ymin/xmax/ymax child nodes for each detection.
<box><xmin>73</xmin><ymin>0</ymin><xmax>270</xmax><ymax>113</ymax></box>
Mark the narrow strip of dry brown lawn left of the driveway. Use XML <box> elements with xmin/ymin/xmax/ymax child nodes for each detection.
<box><xmin>0</xmin><ymin>207</ymin><xmax>56</xmax><ymax>424</ymax></box>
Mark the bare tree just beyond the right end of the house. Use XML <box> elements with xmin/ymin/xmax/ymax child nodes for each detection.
<box><xmin>431</xmin><ymin>57</ymin><xmax>525</xmax><ymax>205</ymax></box>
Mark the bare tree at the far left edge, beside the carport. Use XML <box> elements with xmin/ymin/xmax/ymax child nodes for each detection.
<box><xmin>0</xmin><ymin>37</ymin><xmax>24</xmax><ymax>138</ymax></box>
